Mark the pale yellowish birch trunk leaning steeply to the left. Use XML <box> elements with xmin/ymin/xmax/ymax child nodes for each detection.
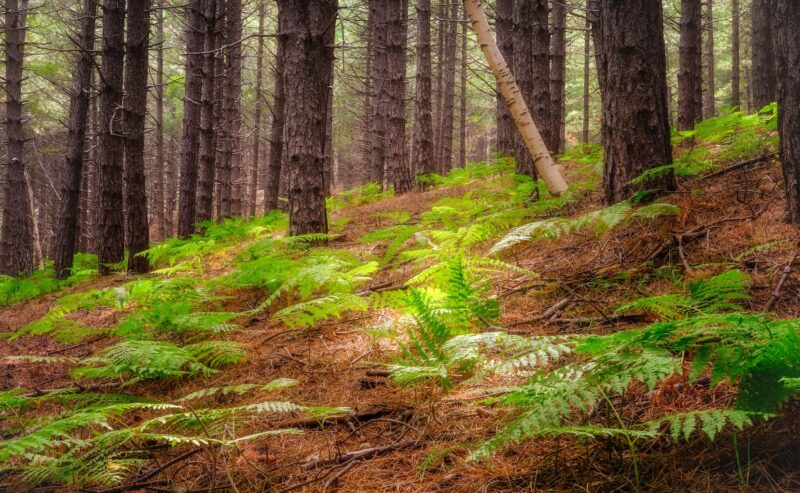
<box><xmin>464</xmin><ymin>0</ymin><xmax>567</xmax><ymax>195</ymax></box>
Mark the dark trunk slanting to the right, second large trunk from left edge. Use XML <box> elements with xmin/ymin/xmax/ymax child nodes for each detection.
<box><xmin>53</xmin><ymin>0</ymin><xmax>97</xmax><ymax>279</ymax></box>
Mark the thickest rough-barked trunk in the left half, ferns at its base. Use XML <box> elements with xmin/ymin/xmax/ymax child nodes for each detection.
<box><xmin>278</xmin><ymin>0</ymin><xmax>338</xmax><ymax>235</ymax></box>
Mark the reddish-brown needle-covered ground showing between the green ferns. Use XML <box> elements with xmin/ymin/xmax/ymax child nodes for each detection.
<box><xmin>0</xmin><ymin>116</ymin><xmax>800</xmax><ymax>493</ymax></box>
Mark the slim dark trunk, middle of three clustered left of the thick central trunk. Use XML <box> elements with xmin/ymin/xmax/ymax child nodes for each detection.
<box><xmin>196</xmin><ymin>0</ymin><xmax>221</xmax><ymax>223</ymax></box>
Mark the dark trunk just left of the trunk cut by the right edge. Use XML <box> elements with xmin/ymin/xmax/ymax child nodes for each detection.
<box><xmin>751</xmin><ymin>0</ymin><xmax>781</xmax><ymax>110</ymax></box>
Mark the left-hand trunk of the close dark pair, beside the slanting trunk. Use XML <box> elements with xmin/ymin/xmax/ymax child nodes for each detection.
<box><xmin>97</xmin><ymin>0</ymin><xmax>125</xmax><ymax>275</ymax></box>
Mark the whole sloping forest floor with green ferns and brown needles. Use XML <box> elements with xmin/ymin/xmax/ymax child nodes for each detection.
<box><xmin>0</xmin><ymin>107</ymin><xmax>800</xmax><ymax>493</ymax></box>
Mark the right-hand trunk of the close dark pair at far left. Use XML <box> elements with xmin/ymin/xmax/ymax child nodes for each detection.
<box><xmin>125</xmin><ymin>0</ymin><xmax>150</xmax><ymax>273</ymax></box>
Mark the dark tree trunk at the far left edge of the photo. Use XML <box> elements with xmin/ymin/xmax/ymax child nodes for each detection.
<box><xmin>0</xmin><ymin>0</ymin><xmax>32</xmax><ymax>276</ymax></box>
